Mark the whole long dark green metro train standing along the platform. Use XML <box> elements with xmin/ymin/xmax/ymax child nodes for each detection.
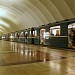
<box><xmin>1</xmin><ymin>18</ymin><xmax>75</xmax><ymax>48</ymax></box>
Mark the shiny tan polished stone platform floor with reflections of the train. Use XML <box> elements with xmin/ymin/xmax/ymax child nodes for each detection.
<box><xmin>0</xmin><ymin>40</ymin><xmax>75</xmax><ymax>75</ymax></box>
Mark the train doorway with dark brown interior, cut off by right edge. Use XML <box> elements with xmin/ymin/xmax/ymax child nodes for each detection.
<box><xmin>68</xmin><ymin>23</ymin><xmax>75</xmax><ymax>48</ymax></box>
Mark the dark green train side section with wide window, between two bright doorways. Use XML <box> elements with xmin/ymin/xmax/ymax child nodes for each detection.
<box><xmin>49</xmin><ymin>21</ymin><xmax>69</xmax><ymax>48</ymax></box>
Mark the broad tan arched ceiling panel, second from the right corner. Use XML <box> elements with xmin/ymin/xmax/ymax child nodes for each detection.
<box><xmin>51</xmin><ymin>0</ymin><xmax>74</xmax><ymax>19</ymax></box>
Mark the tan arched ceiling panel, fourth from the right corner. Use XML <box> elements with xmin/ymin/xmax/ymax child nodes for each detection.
<box><xmin>27</xmin><ymin>0</ymin><xmax>55</xmax><ymax>22</ymax></box>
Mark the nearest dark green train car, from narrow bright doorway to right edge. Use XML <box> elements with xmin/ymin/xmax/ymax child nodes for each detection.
<box><xmin>39</xmin><ymin>19</ymin><xmax>75</xmax><ymax>48</ymax></box>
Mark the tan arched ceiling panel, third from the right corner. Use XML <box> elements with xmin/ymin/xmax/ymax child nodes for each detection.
<box><xmin>40</xmin><ymin>0</ymin><xmax>63</xmax><ymax>21</ymax></box>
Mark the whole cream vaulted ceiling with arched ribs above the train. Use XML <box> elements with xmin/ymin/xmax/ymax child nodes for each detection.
<box><xmin>0</xmin><ymin>0</ymin><xmax>75</xmax><ymax>34</ymax></box>
